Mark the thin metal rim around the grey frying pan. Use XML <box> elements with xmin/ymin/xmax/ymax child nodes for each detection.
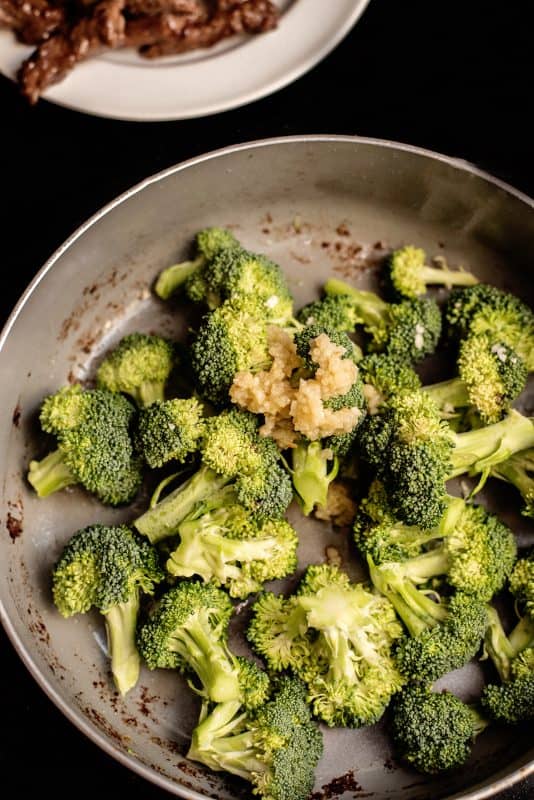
<box><xmin>0</xmin><ymin>134</ymin><xmax>534</xmax><ymax>800</ymax></box>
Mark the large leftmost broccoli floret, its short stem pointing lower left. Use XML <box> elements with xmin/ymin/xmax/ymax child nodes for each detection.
<box><xmin>28</xmin><ymin>385</ymin><xmax>141</xmax><ymax>505</ymax></box>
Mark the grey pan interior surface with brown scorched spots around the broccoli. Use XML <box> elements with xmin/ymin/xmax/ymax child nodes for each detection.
<box><xmin>0</xmin><ymin>137</ymin><xmax>534</xmax><ymax>800</ymax></box>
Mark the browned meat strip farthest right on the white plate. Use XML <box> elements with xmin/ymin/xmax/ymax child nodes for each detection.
<box><xmin>140</xmin><ymin>0</ymin><xmax>278</xmax><ymax>58</ymax></box>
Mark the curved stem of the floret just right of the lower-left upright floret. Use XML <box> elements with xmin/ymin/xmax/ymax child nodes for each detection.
<box><xmin>171</xmin><ymin>609</ymin><xmax>241</xmax><ymax>703</ymax></box>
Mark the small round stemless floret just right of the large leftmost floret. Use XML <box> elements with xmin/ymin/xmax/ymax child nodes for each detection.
<box><xmin>136</xmin><ymin>397</ymin><xmax>204</xmax><ymax>469</ymax></box>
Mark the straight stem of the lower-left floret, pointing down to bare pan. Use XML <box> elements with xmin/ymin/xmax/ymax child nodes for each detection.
<box><xmin>104</xmin><ymin>591</ymin><xmax>141</xmax><ymax>695</ymax></box>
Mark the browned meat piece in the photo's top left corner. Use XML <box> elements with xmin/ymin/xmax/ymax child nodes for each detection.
<box><xmin>0</xmin><ymin>0</ymin><xmax>65</xmax><ymax>44</ymax></box>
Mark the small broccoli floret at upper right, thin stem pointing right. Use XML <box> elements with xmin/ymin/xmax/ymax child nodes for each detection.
<box><xmin>384</xmin><ymin>245</ymin><xmax>478</xmax><ymax>298</ymax></box>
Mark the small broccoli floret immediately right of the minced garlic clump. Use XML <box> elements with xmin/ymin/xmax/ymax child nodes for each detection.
<box><xmin>358</xmin><ymin>353</ymin><xmax>421</xmax><ymax>414</ymax></box>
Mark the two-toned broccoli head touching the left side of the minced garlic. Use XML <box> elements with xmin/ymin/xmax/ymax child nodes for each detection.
<box><xmin>191</xmin><ymin>301</ymin><xmax>270</xmax><ymax>404</ymax></box>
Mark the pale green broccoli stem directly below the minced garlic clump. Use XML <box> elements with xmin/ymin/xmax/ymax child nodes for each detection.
<box><xmin>291</xmin><ymin>441</ymin><xmax>339</xmax><ymax>516</ymax></box>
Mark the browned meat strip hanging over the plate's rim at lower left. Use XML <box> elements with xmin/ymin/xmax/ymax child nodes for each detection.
<box><xmin>18</xmin><ymin>0</ymin><xmax>125</xmax><ymax>103</ymax></box>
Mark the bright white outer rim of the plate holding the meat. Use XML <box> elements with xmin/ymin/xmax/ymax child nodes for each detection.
<box><xmin>2</xmin><ymin>0</ymin><xmax>371</xmax><ymax>122</ymax></box>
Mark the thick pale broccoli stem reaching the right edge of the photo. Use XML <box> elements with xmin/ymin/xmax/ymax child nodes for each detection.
<box><xmin>448</xmin><ymin>410</ymin><xmax>534</xmax><ymax>478</ymax></box>
